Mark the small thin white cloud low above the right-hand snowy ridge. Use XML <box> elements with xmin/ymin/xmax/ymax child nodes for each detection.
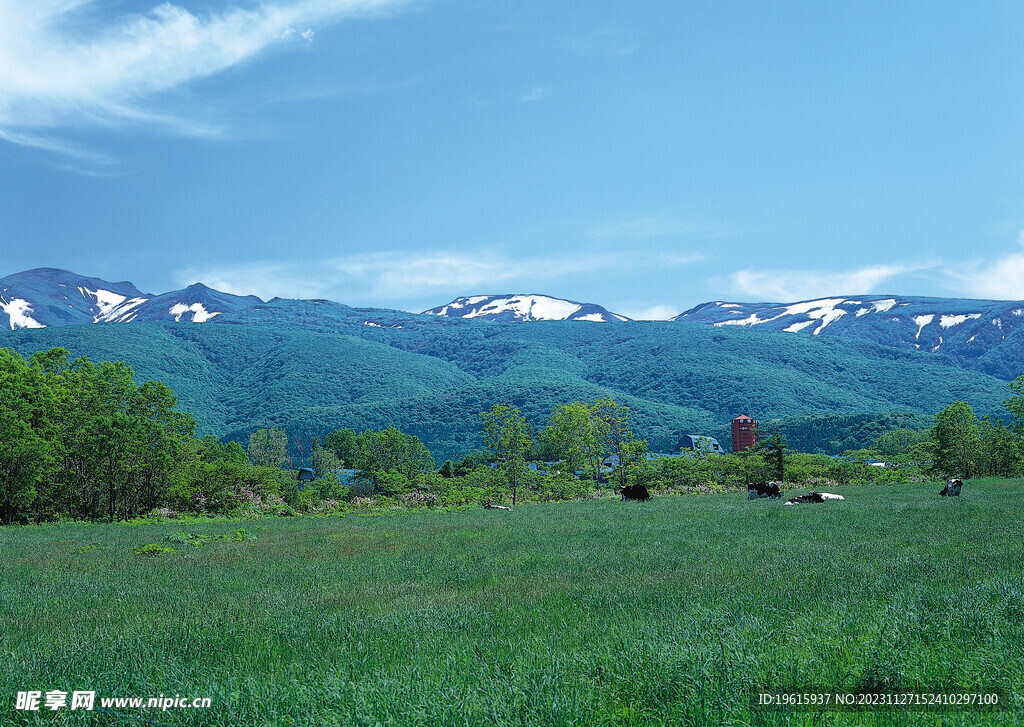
<box><xmin>729</xmin><ymin>265</ymin><xmax>925</xmax><ymax>303</ymax></box>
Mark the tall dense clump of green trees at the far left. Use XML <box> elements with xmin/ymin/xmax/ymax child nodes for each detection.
<box><xmin>0</xmin><ymin>348</ymin><xmax>198</xmax><ymax>519</ymax></box>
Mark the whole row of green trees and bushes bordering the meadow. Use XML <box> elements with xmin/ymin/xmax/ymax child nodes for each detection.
<box><xmin>8</xmin><ymin>348</ymin><xmax>1024</xmax><ymax>522</ymax></box>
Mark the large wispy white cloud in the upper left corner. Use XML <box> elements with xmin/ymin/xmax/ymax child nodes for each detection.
<box><xmin>0</xmin><ymin>0</ymin><xmax>406</xmax><ymax>156</ymax></box>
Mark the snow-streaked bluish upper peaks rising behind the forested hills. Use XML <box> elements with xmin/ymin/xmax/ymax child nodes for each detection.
<box><xmin>8</xmin><ymin>268</ymin><xmax>1024</xmax><ymax>380</ymax></box>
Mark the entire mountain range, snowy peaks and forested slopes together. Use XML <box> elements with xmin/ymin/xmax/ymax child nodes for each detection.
<box><xmin>0</xmin><ymin>268</ymin><xmax>1024</xmax><ymax>460</ymax></box>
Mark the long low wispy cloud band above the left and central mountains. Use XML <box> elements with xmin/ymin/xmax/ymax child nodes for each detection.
<box><xmin>175</xmin><ymin>250</ymin><xmax>704</xmax><ymax>310</ymax></box>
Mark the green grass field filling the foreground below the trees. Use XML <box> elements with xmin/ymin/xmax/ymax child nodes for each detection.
<box><xmin>0</xmin><ymin>480</ymin><xmax>1024</xmax><ymax>725</ymax></box>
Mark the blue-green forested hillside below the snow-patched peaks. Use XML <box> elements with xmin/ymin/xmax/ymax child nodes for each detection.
<box><xmin>0</xmin><ymin>311</ymin><xmax>1008</xmax><ymax>459</ymax></box>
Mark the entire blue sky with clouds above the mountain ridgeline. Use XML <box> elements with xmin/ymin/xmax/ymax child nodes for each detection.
<box><xmin>0</xmin><ymin>0</ymin><xmax>1024</xmax><ymax>317</ymax></box>
